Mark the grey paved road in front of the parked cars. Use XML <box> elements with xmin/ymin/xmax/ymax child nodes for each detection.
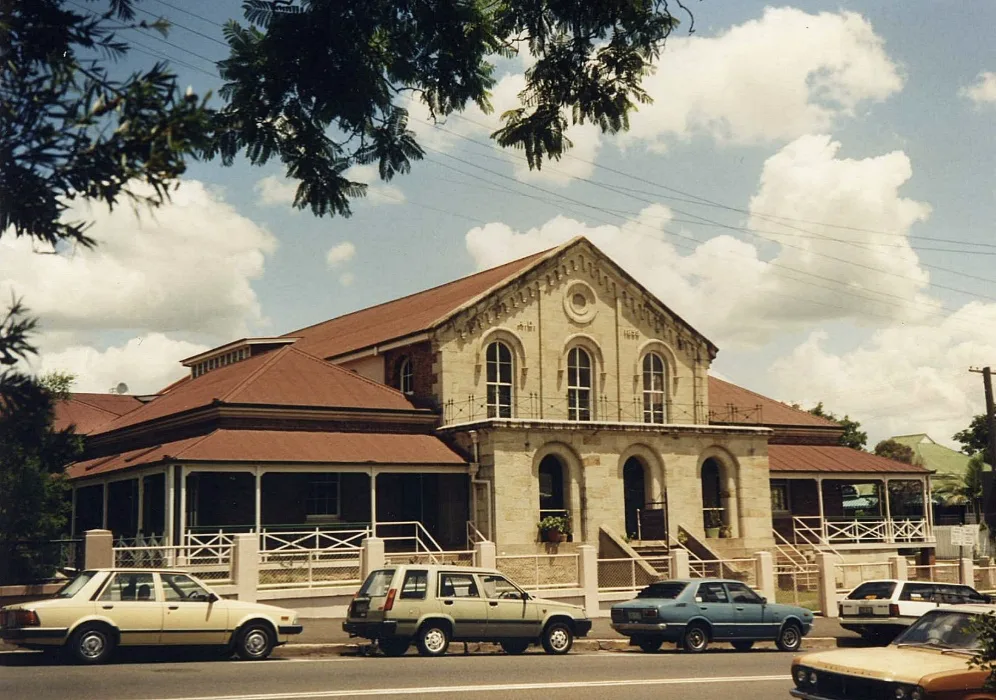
<box><xmin>0</xmin><ymin>648</ymin><xmax>792</xmax><ymax>700</ymax></box>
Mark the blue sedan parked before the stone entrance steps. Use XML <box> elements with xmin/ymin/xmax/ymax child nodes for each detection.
<box><xmin>612</xmin><ymin>578</ymin><xmax>813</xmax><ymax>652</ymax></box>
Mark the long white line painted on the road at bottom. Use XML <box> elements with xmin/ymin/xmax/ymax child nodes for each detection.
<box><xmin>140</xmin><ymin>673</ymin><xmax>792</xmax><ymax>700</ymax></box>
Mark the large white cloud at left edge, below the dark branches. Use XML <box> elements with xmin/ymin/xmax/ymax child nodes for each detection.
<box><xmin>0</xmin><ymin>180</ymin><xmax>276</xmax><ymax>338</ymax></box>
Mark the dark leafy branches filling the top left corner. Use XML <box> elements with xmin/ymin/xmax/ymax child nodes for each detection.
<box><xmin>0</xmin><ymin>0</ymin><xmax>212</xmax><ymax>248</ymax></box>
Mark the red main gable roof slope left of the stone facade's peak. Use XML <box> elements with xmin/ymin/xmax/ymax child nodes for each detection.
<box><xmin>284</xmin><ymin>249</ymin><xmax>555</xmax><ymax>357</ymax></box>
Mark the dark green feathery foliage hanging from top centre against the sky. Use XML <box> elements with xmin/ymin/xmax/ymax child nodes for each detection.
<box><xmin>214</xmin><ymin>0</ymin><xmax>691</xmax><ymax>216</ymax></box>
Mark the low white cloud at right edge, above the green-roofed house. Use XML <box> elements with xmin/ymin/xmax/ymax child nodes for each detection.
<box><xmin>769</xmin><ymin>302</ymin><xmax>996</xmax><ymax>447</ymax></box>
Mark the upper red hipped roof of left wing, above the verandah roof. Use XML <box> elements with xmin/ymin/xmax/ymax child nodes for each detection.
<box><xmin>92</xmin><ymin>346</ymin><xmax>413</xmax><ymax>433</ymax></box>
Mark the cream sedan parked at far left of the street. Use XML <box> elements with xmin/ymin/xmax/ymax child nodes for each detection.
<box><xmin>0</xmin><ymin>569</ymin><xmax>302</xmax><ymax>664</ymax></box>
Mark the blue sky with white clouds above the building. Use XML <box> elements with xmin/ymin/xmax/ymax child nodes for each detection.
<box><xmin>7</xmin><ymin>0</ymin><xmax>996</xmax><ymax>448</ymax></box>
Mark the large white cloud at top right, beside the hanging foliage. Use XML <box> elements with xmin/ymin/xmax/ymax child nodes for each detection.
<box><xmin>621</xmin><ymin>7</ymin><xmax>903</xmax><ymax>148</ymax></box>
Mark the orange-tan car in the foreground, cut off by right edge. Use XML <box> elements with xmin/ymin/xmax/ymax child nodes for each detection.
<box><xmin>790</xmin><ymin>605</ymin><xmax>996</xmax><ymax>700</ymax></box>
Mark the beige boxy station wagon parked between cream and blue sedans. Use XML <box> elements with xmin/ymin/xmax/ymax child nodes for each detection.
<box><xmin>342</xmin><ymin>564</ymin><xmax>591</xmax><ymax>656</ymax></box>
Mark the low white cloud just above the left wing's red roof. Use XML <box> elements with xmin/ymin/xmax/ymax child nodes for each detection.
<box><xmin>33</xmin><ymin>333</ymin><xmax>208</xmax><ymax>394</ymax></box>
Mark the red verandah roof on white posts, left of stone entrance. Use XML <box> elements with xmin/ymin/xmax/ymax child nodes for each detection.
<box><xmin>66</xmin><ymin>430</ymin><xmax>467</xmax><ymax>479</ymax></box>
